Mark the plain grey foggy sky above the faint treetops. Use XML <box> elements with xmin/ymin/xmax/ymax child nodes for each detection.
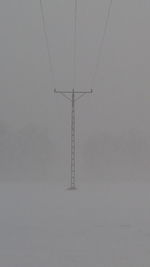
<box><xmin>0</xmin><ymin>0</ymin><xmax>150</xmax><ymax>181</ymax></box>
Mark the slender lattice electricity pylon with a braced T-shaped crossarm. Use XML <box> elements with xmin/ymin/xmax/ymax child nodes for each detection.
<box><xmin>54</xmin><ymin>89</ymin><xmax>93</xmax><ymax>190</ymax></box>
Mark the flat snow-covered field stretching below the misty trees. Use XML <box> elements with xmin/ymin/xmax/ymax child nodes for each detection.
<box><xmin>0</xmin><ymin>182</ymin><xmax>150</xmax><ymax>267</ymax></box>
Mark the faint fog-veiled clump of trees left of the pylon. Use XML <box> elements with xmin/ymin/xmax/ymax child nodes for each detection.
<box><xmin>0</xmin><ymin>121</ymin><xmax>54</xmax><ymax>180</ymax></box>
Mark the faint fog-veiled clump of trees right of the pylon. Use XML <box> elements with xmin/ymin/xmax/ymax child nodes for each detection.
<box><xmin>83</xmin><ymin>129</ymin><xmax>150</xmax><ymax>179</ymax></box>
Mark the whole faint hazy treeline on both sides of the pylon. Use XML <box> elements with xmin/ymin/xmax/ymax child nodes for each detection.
<box><xmin>0</xmin><ymin>121</ymin><xmax>150</xmax><ymax>182</ymax></box>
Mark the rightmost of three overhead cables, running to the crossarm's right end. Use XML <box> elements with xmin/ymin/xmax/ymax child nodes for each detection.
<box><xmin>91</xmin><ymin>0</ymin><xmax>113</xmax><ymax>88</ymax></box>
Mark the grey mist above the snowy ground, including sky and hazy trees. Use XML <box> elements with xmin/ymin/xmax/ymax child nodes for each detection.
<box><xmin>0</xmin><ymin>0</ymin><xmax>150</xmax><ymax>182</ymax></box>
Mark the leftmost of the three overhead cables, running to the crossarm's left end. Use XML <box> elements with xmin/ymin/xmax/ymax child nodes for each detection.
<box><xmin>40</xmin><ymin>0</ymin><xmax>56</xmax><ymax>88</ymax></box>
